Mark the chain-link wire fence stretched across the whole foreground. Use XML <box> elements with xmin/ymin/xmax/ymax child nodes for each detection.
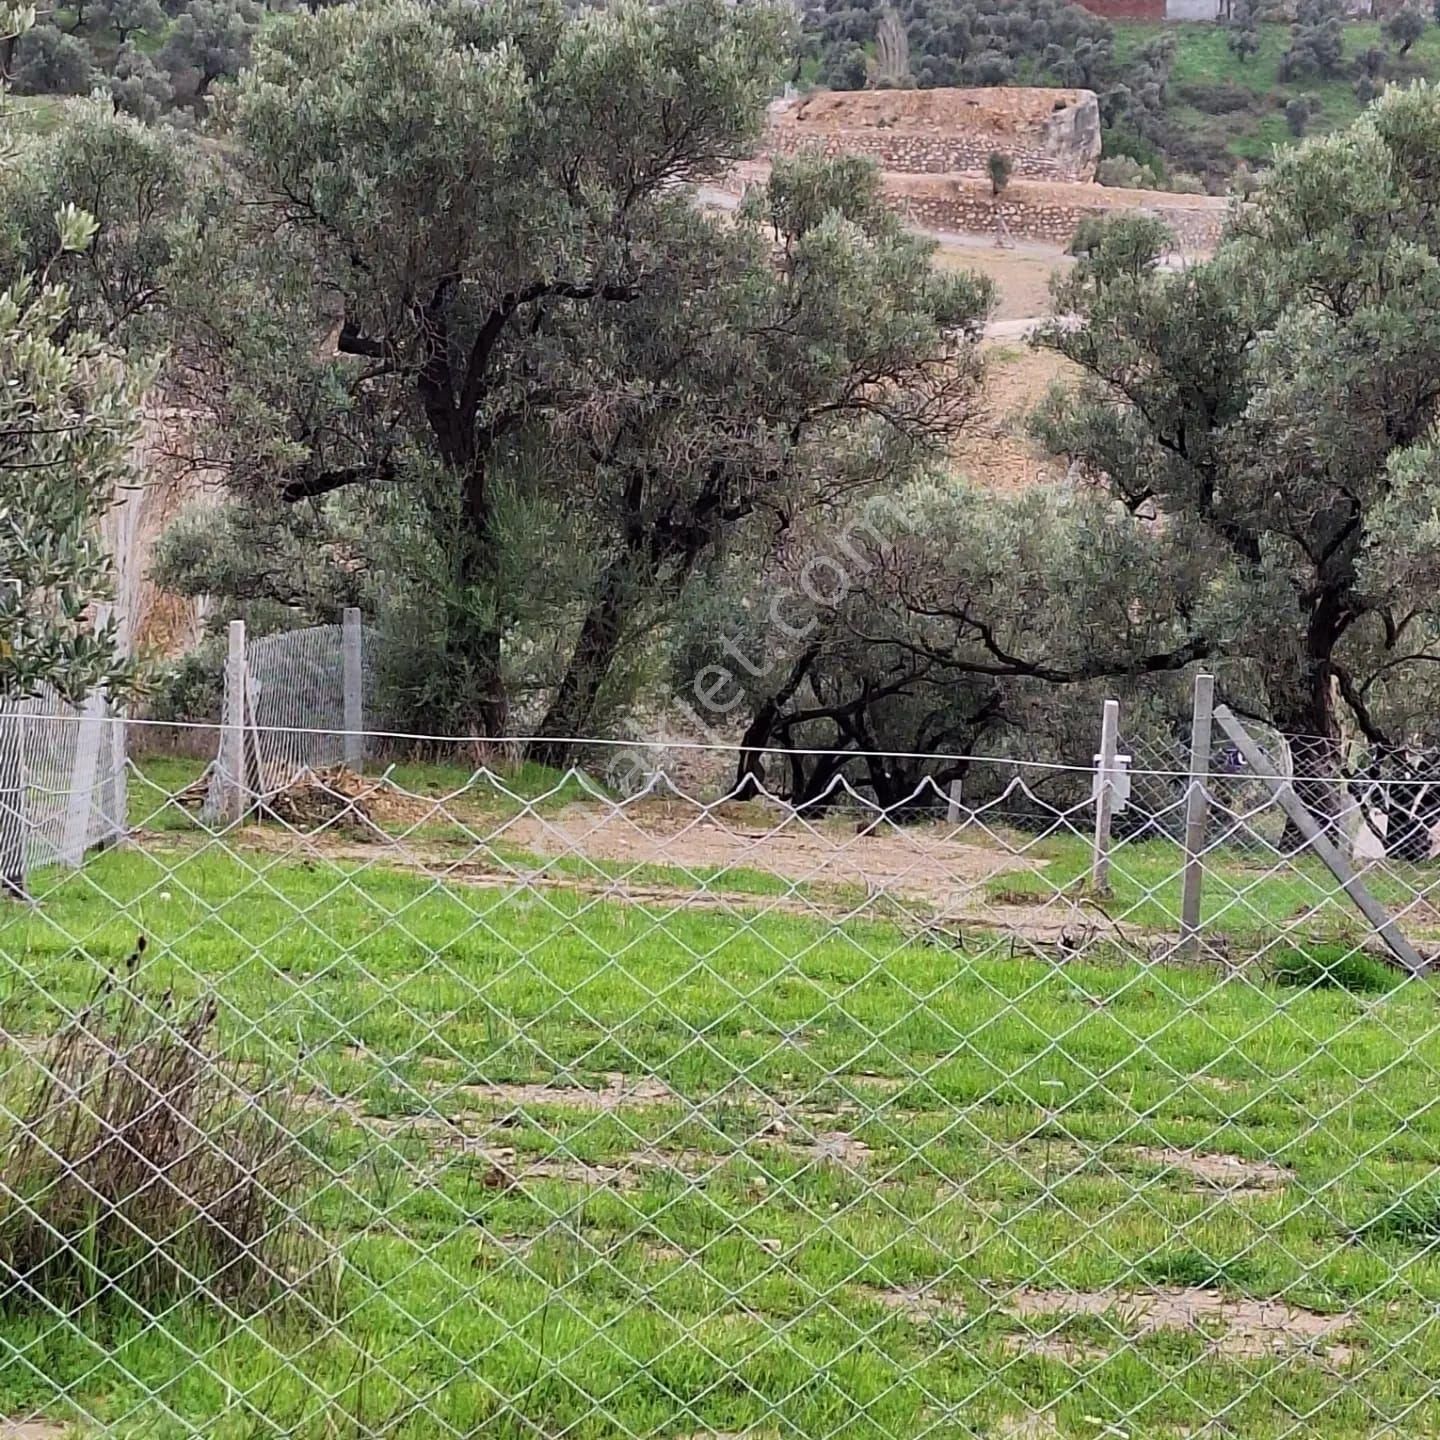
<box><xmin>0</xmin><ymin>710</ymin><xmax>1440</xmax><ymax>1440</ymax></box>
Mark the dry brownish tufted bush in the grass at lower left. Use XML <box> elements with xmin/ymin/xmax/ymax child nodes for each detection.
<box><xmin>0</xmin><ymin>939</ymin><xmax>318</xmax><ymax>1313</ymax></box>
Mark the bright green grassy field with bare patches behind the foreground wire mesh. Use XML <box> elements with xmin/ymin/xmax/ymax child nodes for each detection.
<box><xmin>0</xmin><ymin>762</ymin><xmax>1440</xmax><ymax>1440</ymax></box>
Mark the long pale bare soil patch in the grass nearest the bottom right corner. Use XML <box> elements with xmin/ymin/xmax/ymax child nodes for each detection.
<box><xmin>1007</xmin><ymin>1286</ymin><xmax>1354</xmax><ymax>1365</ymax></box>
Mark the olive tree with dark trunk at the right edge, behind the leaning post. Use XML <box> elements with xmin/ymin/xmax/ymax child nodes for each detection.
<box><xmin>1040</xmin><ymin>86</ymin><xmax>1440</xmax><ymax>835</ymax></box>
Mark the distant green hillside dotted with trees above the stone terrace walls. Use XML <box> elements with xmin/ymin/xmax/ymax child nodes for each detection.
<box><xmin>795</xmin><ymin>0</ymin><xmax>1440</xmax><ymax>190</ymax></box>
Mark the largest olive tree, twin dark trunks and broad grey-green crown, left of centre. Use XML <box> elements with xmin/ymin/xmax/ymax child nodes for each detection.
<box><xmin>154</xmin><ymin>0</ymin><xmax>989</xmax><ymax>759</ymax></box>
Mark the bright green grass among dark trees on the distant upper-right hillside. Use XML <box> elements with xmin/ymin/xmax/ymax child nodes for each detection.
<box><xmin>1115</xmin><ymin>20</ymin><xmax>1440</xmax><ymax>164</ymax></box>
